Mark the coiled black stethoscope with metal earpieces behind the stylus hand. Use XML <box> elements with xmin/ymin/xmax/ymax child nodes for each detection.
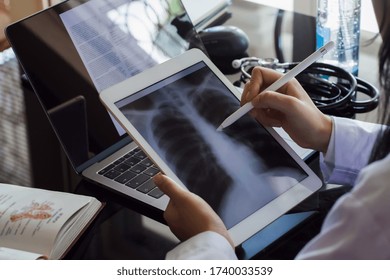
<box><xmin>232</xmin><ymin>57</ymin><xmax>379</xmax><ymax>117</ymax></box>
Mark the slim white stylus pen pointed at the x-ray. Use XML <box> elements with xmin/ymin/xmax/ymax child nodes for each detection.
<box><xmin>217</xmin><ymin>41</ymin><xmax>334</xmax><ymax>131</ymax></box>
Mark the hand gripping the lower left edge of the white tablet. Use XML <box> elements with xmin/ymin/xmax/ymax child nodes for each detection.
<box><xmin>154</xmin><ymin>174</ymin><xmax>234</xmax><ymax>248</ymax></box>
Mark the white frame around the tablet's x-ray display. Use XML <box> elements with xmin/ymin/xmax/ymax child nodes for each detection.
<box><xmin>100</xmin><ymin>49</ymin><xmax>322</xmax><ymax>245</ymax></box>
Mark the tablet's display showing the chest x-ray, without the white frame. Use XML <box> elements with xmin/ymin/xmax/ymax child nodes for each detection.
<box><xmin>115</xmin><ymin>62</ymin><xmax>308</xmax><ymax>228</ymax></box>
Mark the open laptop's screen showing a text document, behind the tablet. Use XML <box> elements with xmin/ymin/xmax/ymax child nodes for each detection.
<box><xmin>6</xmin><ymin>0</ymin><xmax>206</xmax><ymax>172</ymax></box>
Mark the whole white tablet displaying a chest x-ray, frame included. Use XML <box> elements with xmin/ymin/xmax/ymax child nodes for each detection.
<box><xmin>100</xmin><ymin>49</ymin><xmax>322</xmax><ymax>245</ymax></box>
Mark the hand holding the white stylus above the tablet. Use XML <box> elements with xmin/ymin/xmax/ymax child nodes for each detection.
<box><xmin>241</xmin><ymin>67</ymin><xmax>332</xmax><ymax>153</ymax></box>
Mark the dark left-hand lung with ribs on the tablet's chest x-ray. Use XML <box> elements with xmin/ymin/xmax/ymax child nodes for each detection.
<box><xmin>152</xmin><ymin>85</ymin><xmax>231</xmax><ymax>208</ymax></box>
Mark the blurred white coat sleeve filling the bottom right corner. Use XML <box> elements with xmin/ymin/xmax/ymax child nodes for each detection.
<box><xmin>297</xmin><ymin>155</ymin><xmax>390</xmax><ymax>260</ymax></box>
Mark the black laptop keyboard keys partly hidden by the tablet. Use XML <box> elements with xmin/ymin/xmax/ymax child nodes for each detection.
<box><xmin>98</xmin><ymin>148</ymin><xmax>164</xmax><ymax>199</ymax></box>
